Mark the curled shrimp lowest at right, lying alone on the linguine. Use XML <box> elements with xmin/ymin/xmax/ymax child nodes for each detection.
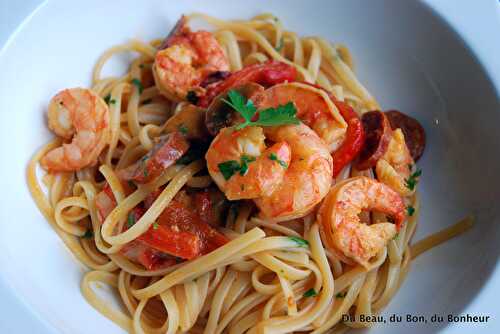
<box><xmin>318</xmin><ymin>176</ymin><xmax>406</xmax><ymax>267</ymax></box>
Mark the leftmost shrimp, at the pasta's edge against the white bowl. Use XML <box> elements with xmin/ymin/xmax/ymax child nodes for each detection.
<box><xmin>41</xmin><ymin>88</ymin><xmax>109</xmax><ymax>172</ymax></box>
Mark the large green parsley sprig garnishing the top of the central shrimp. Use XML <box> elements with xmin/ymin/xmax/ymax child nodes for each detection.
<box><xmin>223</xmin><ymin>90</ymin><xmax>300</xmax><ymax>130</ymax></box>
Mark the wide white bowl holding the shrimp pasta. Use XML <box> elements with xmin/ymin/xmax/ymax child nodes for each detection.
<box><xmin>0</xmin><ymin>0</ymin><xmax>500</xmax><ymax>333</ymax></box>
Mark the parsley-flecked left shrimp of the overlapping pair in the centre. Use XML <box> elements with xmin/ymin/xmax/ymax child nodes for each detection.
<box><xmin>205</xmin><ymin>126</ymin><xmax>291</xmax><ymax>200</ymax></box>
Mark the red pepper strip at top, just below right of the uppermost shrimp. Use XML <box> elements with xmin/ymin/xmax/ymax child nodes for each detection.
<box><xmin>198</xmin><ymin>60</ymin><xmax>297</xmax><ymax>108</ymax></box>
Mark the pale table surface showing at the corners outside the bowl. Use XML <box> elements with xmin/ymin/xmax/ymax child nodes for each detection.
<box><xmin>0</xmin><ymin>0</ymin><xmax>500</xmax><ymax>334</ymax></box>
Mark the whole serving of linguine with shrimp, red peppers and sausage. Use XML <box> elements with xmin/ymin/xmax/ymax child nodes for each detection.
<box><xmin>27</xmin><ymin>14</ymin><xmax>472</xmax><ymax>333</ymax></box>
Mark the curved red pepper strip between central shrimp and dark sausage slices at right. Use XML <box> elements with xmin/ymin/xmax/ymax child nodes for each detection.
<box><xmin>332</xmin><ymin>98</ymin><xmax>365</xmax><ymax>177</ymax></box>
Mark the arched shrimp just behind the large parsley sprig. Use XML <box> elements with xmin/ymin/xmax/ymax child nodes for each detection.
<box><xmin>256</xmin><ymin>82</ymin><xmax>347</xmax><ymax>151</ymax></box>
